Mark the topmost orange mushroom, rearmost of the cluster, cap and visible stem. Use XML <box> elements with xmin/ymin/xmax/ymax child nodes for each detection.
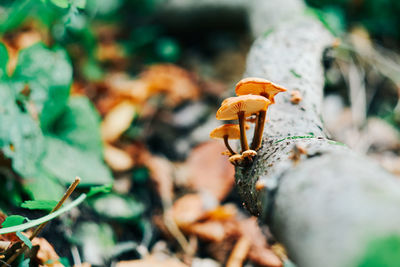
<box><xmin>235</xmin><ymin>77</ymin><xmax>286</xmax><ymax>150</ymax></box>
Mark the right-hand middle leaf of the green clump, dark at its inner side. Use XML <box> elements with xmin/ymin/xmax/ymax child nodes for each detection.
<box><xmin>52</xmin><ymin>96</ymin><xmax>103</xmax><ymax>157</ymax></box>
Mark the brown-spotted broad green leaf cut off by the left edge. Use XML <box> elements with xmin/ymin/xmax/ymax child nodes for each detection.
<box><xmin>0</xmin><ymin>82</ymin><xmax>44</xmax><ymax>178</ymax></box>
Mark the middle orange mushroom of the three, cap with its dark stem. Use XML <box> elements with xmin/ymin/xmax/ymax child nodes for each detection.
<box><xmin>216</xmin><ymin>95</ymin><xmax>270</xmax><ymax>153</ymax></box>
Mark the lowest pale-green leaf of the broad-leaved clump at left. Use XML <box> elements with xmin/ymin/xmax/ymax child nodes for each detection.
<box><xmin>42</xmin><ymin>136</ymin><xmax>113</xmax><ymax>185</ymax></box>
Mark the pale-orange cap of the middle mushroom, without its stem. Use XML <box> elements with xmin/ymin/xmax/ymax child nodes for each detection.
<box><xmin>216</xmin><ymin>95</ymin><xmax>271</xmax><ymax>120</ymax></box>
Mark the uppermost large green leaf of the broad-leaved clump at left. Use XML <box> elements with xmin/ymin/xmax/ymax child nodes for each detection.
<box><xmin>13</xmin><ymin>43</ymin><xmax>72</xmax><ymax>130</ymax></box>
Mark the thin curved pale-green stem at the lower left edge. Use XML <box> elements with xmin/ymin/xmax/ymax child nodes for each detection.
<box><xmin>0</xmin><ymin>194</ymin><xmax>87</xmax><ymax>235</ymax></box>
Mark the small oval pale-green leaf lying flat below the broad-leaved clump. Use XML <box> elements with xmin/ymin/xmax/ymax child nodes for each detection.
<box><xmin>90</xmin><ymin>194</ymin><xmax>144</xmax><ymax>220</ymax></box>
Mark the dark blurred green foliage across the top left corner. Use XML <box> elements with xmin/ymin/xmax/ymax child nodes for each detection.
<box><xmin>0</xmin><ymin>0</ymin><xmax>180</xmax><ymax>78</ymax></box>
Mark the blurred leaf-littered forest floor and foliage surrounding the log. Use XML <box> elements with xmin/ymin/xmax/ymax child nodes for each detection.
<box><xmin>0</xmin><ymin>0</ymin><xmax>400</xmax><ymax>267</ymax></box>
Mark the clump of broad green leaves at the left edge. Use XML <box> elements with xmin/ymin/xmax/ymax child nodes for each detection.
<box><xmin>0</xmin><ymin>43</ymin><xmax>112</xmax><ymax>200</ymax></box>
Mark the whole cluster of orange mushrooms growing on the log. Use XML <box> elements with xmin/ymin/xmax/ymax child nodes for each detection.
<box><xmin>210</xmin><ymin>77</ymin><xmax>286</xmax><ymax>165</ymax></box>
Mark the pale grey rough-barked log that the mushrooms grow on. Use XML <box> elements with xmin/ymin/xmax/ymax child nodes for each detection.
<box><xmin>236</xmin><ymin>1</ymin><xmax>400</xmax><ymax>267</ymax></box>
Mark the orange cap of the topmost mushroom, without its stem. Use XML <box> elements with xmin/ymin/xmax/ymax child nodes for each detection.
<box><xmin>235</xmin><ymin>77</ymin><xmax>286</xmax><ymax>104</ymax></box>
